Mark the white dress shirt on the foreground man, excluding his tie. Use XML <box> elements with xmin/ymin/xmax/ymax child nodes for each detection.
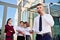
<box><xmin>33</xmin><ymin>14</ymin><xmax>54</xmax><ymax>34</ymax></box>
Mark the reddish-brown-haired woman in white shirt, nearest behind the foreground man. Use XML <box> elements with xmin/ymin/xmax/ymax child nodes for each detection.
<box><xmin>24</xmin><ymin>22</ymin><xmax>31</xmax><ymax>40</ymax></box>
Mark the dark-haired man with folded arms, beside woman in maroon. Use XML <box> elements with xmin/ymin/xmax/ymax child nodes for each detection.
<box><xmin>16</xmin><ymin>21</ymin><xmax>25</xmax><ymax>40</ymax></box>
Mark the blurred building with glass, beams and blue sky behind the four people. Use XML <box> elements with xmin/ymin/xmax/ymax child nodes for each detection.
<box><xmin>0</xmin><ymin>0</ymin><xmax>60</xmax><ymax>40</ymax></box>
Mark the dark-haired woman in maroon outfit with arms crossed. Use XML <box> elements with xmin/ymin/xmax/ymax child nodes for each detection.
<box><xmin>5</xmin><ymin>18</ymin><xmax>15</xmax><ymax>40</ymax></box>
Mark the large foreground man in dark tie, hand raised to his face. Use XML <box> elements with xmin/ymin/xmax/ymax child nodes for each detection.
<box><xmin>33</xmin><ymin>3</ymin><xmax>54</xmax><ymax>40</ymax></box>
